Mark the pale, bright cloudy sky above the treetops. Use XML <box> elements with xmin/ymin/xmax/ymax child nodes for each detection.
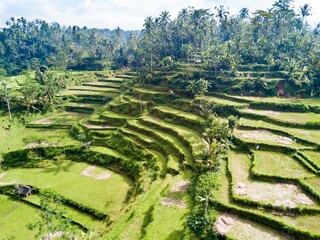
<box><xmin>0</xmin><ymin>0</ymin><xmax>320</xmax><ymax>30</ymax></box>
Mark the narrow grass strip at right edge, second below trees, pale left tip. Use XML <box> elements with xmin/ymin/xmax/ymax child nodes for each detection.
<box><xmin>241</xmin><ymin>109</ymin><xmax>320</xmax><ymax>124</ymax></box>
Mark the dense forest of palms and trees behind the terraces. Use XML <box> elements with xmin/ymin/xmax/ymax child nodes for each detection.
<box><xmin>0</xmin><ymin>0</ymin><xmax>320</xmax><ymax>94</ymax></box>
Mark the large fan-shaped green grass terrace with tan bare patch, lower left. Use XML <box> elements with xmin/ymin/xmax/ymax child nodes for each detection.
<box><xmin>0</xmin><ymin>161</ymin><xmax>132</xmax><ymax>217</ymax></box>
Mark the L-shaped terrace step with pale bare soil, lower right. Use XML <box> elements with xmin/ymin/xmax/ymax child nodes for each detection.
<box><xmin>228</xmin><ymin>151</ymin><xmax>320</xmax><ymax>213</ymax></box>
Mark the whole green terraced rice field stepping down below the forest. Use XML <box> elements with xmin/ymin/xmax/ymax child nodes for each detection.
<box><xmin>0</xmin><ymin>70</ymin><xmax>320</xmax><ymax>240</ymax></box>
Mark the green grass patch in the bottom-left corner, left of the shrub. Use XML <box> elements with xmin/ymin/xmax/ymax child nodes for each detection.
<box><xmin>0</xmin><ymin>194</ymin><xmax>37</xmax><ymax>240</ymax></box>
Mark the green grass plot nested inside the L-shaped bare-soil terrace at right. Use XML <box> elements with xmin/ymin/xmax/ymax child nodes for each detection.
<box><xmin>253</xmin><ymin>151</ymin><xmax>314</xmax><ymax>179</ymax></box>
